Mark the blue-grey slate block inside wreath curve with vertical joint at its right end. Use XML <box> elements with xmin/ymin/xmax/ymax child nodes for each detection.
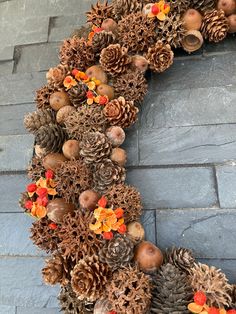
<box><xmin>127</xmin><ymin>167</ymin><xmax>217</xmax><ymax>209</ymax></box>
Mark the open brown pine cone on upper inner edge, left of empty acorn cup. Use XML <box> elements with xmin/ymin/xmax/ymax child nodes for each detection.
<box><xmin>145</xmin><ymin>41</ymin><xmax>174</xmax><ymax>73</ymax></box>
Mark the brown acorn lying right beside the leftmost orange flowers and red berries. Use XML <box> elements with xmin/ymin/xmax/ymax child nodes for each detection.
<box><xmin>47</xmin><ymin>198</ymin><xmax>76</xmax><ymax>224</ymax></box>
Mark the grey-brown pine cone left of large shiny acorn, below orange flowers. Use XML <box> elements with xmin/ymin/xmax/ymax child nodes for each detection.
<box><xmin>99</xmin><ymin>234</ymin><xmax>134</xmax><ymax>270</ymax></box>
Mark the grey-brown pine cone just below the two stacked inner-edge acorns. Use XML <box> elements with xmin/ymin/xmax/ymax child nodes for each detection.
<box><xmin>93</xmin><ymin>159</ymin><xmax>126</xmax><ymax>194</ymax></box>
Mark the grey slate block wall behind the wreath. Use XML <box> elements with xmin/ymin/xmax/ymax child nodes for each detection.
<box><xmin>0</xmin><ymin>0</ymin><xmax>236</xmax><ymax>314</ymax></box>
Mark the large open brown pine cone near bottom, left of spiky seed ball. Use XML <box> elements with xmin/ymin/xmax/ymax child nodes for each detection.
<box><xmin>71</xmin><ymin>255</ymin><xmax>110</xmax><ymax>301</ymax></box>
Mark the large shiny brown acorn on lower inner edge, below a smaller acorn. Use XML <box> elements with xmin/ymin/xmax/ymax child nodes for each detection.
<box><xmin>134</xmin><ymin>241</ymin><xmax>163</xmax><ymax>273</ymax></box>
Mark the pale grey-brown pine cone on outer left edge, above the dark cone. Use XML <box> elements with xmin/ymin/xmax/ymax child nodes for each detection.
<box><xmin>24</xmin><ymin>109</ymin><xmax>56</xmax><ymax>133</ymax></box>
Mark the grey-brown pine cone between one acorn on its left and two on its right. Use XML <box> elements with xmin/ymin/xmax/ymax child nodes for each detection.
<box><xmin>80</xmin><ymin>132</ymin><xmax>112</xmax><ymax>164</ymax></box>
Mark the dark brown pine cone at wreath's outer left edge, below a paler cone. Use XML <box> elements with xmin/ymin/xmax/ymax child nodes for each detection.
<box><xmin>35</xmin><ymin>124</ymin><xmax>67</xmax><ymax>153</ymax></box>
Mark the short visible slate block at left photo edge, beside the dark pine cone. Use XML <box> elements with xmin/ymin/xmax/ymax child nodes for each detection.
<box><xmin>0</xmin><ymin>135</ymin><xmax>34</xmax><ymax>171</ymax></box>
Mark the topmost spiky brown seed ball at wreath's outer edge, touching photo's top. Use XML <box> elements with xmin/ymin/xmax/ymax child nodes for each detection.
<box><xmin>86</xmin><ymin>0</ymin><xmax>113</xmax><ymax>27</ymax></box>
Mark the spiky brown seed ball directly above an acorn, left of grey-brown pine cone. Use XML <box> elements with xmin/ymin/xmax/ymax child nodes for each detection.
<box><xmin>55</xmin><ymin>160</ymin><xmax>92</xmax><ymax>204</ymax></box>
